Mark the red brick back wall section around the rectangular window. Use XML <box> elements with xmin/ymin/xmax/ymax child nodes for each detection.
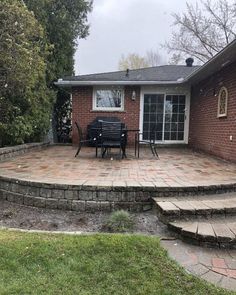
<box><xmin>72</xmin><ymin>86</ymin><xmax>140</xmax><ymax>144</ymax></box>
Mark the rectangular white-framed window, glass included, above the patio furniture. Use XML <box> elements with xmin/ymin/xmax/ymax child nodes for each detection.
<box><xmin>93</xmin><ymin>87</ymin><xmax>124</xmax><ymax>111</ymax></box>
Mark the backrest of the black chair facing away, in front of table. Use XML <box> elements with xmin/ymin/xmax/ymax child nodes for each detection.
<box><xmin>100</xmin><ymin>121</ymin><xmax>124</xmax><ymax>141</ymax></box>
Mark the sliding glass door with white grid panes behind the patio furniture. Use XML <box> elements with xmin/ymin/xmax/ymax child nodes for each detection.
<box><xmin>143</xmin><ymin>94</ymin><xmax>186</xmax><ymax>142</ymax></box>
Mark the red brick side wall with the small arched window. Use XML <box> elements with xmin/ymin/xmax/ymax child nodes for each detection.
<box><xmin>189</xmin><ymin>63</ymin><xmax>236</xmax><ymax>162</ymax></box>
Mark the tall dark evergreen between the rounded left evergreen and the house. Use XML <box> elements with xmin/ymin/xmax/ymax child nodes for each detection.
<box><xmin>24</xmin><ymin>0</ymin><xmax>92</xmax><ymax>142</ymax></box>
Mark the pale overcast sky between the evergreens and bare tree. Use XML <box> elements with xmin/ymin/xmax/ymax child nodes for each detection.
<box><xmin>75</xmin><ymin>0</ymin><xmax>200</xmax><ymax>75</ymax></box>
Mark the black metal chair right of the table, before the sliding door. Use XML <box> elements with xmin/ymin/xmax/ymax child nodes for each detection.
<box><xmin>135</xmin><ymin>126</ymin><xmax>159</xmax><ymax>159</ymax></box>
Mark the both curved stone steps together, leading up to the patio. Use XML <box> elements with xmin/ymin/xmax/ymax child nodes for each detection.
<box><xmin>154</xmin><ymin>192</ymin><xmax>236</xmax><ymax>249</ymax></box>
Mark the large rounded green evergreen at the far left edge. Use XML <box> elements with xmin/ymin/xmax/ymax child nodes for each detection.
<box><xmin>0</xmin><ymin>0</ymin><xmax>53</xmax><ymax>146</ymax></box>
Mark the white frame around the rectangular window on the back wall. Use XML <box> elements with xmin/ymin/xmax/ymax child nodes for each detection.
<box><xmin>93</xmin><ymin>85</ymin><xmax>124</xmax><ymax>112</ymax></box>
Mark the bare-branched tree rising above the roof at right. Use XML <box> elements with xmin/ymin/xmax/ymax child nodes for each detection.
<box><xmin>164</xmin><ymin>0</ymin><xmax>236</xmax><ymax>63</ymax></box>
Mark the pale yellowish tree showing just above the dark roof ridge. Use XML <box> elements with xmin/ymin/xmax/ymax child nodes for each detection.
<box><xmin>118</xmin><ymin>50</ymin><xmax>162</xmax><ymax>71</ymax></box>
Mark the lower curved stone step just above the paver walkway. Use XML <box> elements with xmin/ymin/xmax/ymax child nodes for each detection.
<box><xmin>168</xmin><ymin>216</ymin><xmax>236</xmax><ymax>249</ymax></box>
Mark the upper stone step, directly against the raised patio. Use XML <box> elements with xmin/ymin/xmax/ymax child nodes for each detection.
<box><xmin>153</xmin><ymin>192</ymin><xmax>236</xmax><ymax>224</ymax></box>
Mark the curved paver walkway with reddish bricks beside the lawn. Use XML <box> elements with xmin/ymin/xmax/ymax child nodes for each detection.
<box><xmin>161</xmin><ymin>240</ymin><xmax>236</xmax><ymax>294</ymax></box>
